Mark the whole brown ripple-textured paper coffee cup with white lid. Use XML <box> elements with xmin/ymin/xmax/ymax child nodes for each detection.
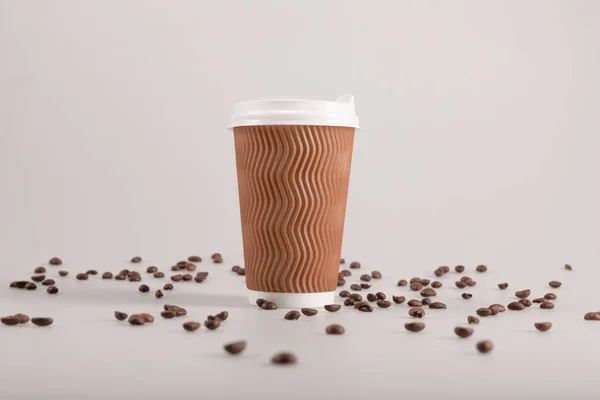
<box><xmin>229</xmin><ymin>95</ymin><xmax>359</xmax><ymax>308</ymax></box>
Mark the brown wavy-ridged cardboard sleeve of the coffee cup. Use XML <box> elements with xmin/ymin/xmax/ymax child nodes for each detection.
<box><xmin>234</xmin><ymin>125</ymin><xmax>354</xmax><ymax>293</ymax></box>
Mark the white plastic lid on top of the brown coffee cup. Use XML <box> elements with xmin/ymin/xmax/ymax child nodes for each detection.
<box><xmin>228</xmin><ymin>94</ymin><xmax>360</xmax><ymax>129</ymax></box>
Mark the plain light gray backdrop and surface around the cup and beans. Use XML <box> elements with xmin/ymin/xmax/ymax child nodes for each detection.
<box><xmin>0</xmin><ymin>0</ymin><xmax>600</xmax><ymax>399</ymax></box>
